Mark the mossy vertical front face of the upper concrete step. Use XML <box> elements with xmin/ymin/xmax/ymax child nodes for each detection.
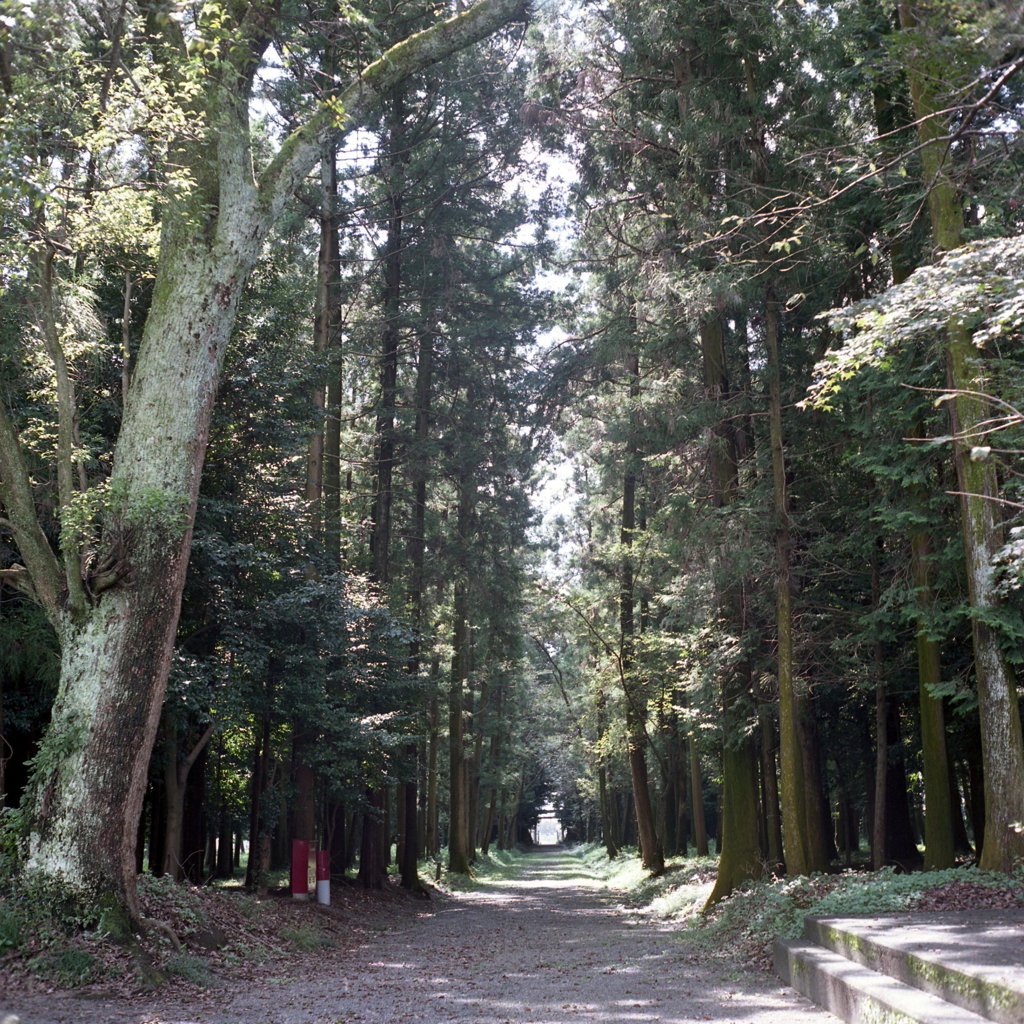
<box><xmin>804</xmin><ymin>916</ymin><xmax>1024</xmax><ymax>1024</ymax></box>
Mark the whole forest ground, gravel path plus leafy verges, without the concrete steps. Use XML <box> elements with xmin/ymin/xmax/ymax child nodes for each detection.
<box><xmin>0</xmin><ymin>847</ymin><xmax>1024</xmax><ymax>1024</ymax></box>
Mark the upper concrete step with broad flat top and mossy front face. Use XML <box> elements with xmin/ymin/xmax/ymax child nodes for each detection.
<box><xmin>804</xmin><ymin>910</ymin><xmax>1024</xmax><ymax>1024</ymax></box>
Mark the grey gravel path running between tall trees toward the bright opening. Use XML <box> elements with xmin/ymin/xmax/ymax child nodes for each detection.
<box><xmin>8</xmin><ymin>851</ymin><xmax>836</xmax><ymax>1024</ymax></box>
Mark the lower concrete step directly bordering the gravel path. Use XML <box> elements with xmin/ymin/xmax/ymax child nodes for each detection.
<box><xmin>774</xmin><ymin>939</ymin><xmax>985</xmax><ymax>1024</ymax></box>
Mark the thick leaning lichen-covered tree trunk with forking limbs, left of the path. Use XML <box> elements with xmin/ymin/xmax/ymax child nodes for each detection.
<box><xmin>0</xmin><ymin>0</ymin><xmax>522</xmax><ymax>920</ymax></box>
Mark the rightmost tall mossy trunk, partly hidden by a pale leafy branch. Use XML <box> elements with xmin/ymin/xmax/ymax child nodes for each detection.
<box><xmin>898</xmin><ymin>0</ymin><xmax>1024</xmax><ymax>871</ymax></box>
